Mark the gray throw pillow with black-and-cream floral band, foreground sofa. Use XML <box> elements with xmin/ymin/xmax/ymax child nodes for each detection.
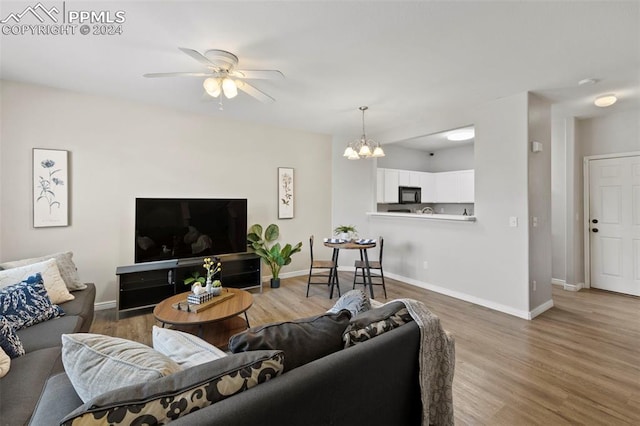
<box><xmin>62</xmin><ymin>351</ymin><xmax>284</xmax><ymax>426</ymax></box>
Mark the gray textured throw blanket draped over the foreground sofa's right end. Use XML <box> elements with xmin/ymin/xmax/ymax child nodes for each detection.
<box><xmin>394</xmin><ymin>299</ymin><xmax>456</xmax><ymax>426</ymax></box>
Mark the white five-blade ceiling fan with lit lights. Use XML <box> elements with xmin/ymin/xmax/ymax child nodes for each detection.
<box><xmin>144</xmin><ymin>47</ymin><xmax>284</xmax><ymax>103</ymax></box>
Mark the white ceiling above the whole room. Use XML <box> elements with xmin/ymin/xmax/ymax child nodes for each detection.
<box><xmin>0</xmin><ymin>0</ymin><xmax>640</xmax><ymax>150</ymax></box>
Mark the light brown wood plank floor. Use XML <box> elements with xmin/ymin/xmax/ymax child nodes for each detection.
<box><xmin>92</xmin><ymin>273</ymin><xmax>640</xmax><ymax>425</ymax></box>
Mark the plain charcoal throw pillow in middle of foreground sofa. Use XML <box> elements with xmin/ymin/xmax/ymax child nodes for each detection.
<box><xmin>229</xmin><ymin>310</ymin><xmax>350</xmax><ymax>371</ymax></box>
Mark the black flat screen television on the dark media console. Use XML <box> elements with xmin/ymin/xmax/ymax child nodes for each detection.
<box><xmin>135</xmin><ymin>198</ymin><xmax>247</xmax><ymax>263</ymax></box>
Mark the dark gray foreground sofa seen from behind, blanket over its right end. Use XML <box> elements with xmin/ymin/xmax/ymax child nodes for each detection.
<box><xmin>32</xmin><ymin>322</ymin><xmax>422</xmax><ymax>426</ymax></box>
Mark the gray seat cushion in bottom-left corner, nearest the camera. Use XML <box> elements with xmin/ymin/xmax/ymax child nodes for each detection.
<box><xmin>0</xmin><ymin>346</ymin><xmax>63</xmax><ymax>426</ymax></box>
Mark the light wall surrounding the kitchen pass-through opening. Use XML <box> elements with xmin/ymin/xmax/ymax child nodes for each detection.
<box><xmin>334</xmin><ymin>93</ymin><xmax>529</xmax><ymax>316</ymax></box>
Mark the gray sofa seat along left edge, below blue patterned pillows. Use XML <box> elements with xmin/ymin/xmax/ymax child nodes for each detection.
<box><xmin>0</xmin><ymin>283</ymin><xmax>96</xmax><ymax>426</ymax></box>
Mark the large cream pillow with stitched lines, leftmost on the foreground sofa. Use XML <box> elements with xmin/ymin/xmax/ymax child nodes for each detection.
<box><xmin>62</xmin><ymin>333</ymin><xmax>180</xmax><ymax>402</ymax></box>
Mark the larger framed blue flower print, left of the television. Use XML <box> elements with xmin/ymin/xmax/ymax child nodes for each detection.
<box><xmin>33</xmin><ymin>148</ymin><xmax>69</xmax><ymax>228</ymax></box>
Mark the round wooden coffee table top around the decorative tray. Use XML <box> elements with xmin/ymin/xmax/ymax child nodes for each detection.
<box><xmin>153</xmin><ymin>287</ymin><xmax>253</xmax><ymax>325</ymax></box>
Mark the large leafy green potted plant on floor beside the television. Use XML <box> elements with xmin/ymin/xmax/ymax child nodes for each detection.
<box><xmin>247</xmin><ymin>223</ymin><xmax>302</xmax><ymax>288</ymax></box>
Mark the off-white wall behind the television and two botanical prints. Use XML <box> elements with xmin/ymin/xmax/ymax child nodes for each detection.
<box><xmin>0</xmin><ymin>81</ymin><xmax>332</xmax><ymax>302</ymax></box>
